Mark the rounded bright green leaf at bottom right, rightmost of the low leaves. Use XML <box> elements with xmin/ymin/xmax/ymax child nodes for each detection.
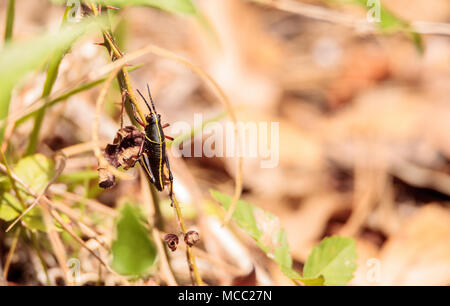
<box><xmin>301</xmin><ymin>236</ymin><xmax>356</xmax><ymax>286</ymax></box>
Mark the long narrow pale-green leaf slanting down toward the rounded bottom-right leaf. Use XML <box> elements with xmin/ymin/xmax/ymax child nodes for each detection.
<box><xmin>210</xmin><ymin>189</ymin><xmax>301</xmax><ymax>279</ymax></box>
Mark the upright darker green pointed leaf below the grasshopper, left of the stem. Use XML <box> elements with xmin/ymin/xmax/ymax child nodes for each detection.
<box><xmin>112</xmin><ymin>204</ymin><xmax>157</xmax><ymax>276</ymax></box>
